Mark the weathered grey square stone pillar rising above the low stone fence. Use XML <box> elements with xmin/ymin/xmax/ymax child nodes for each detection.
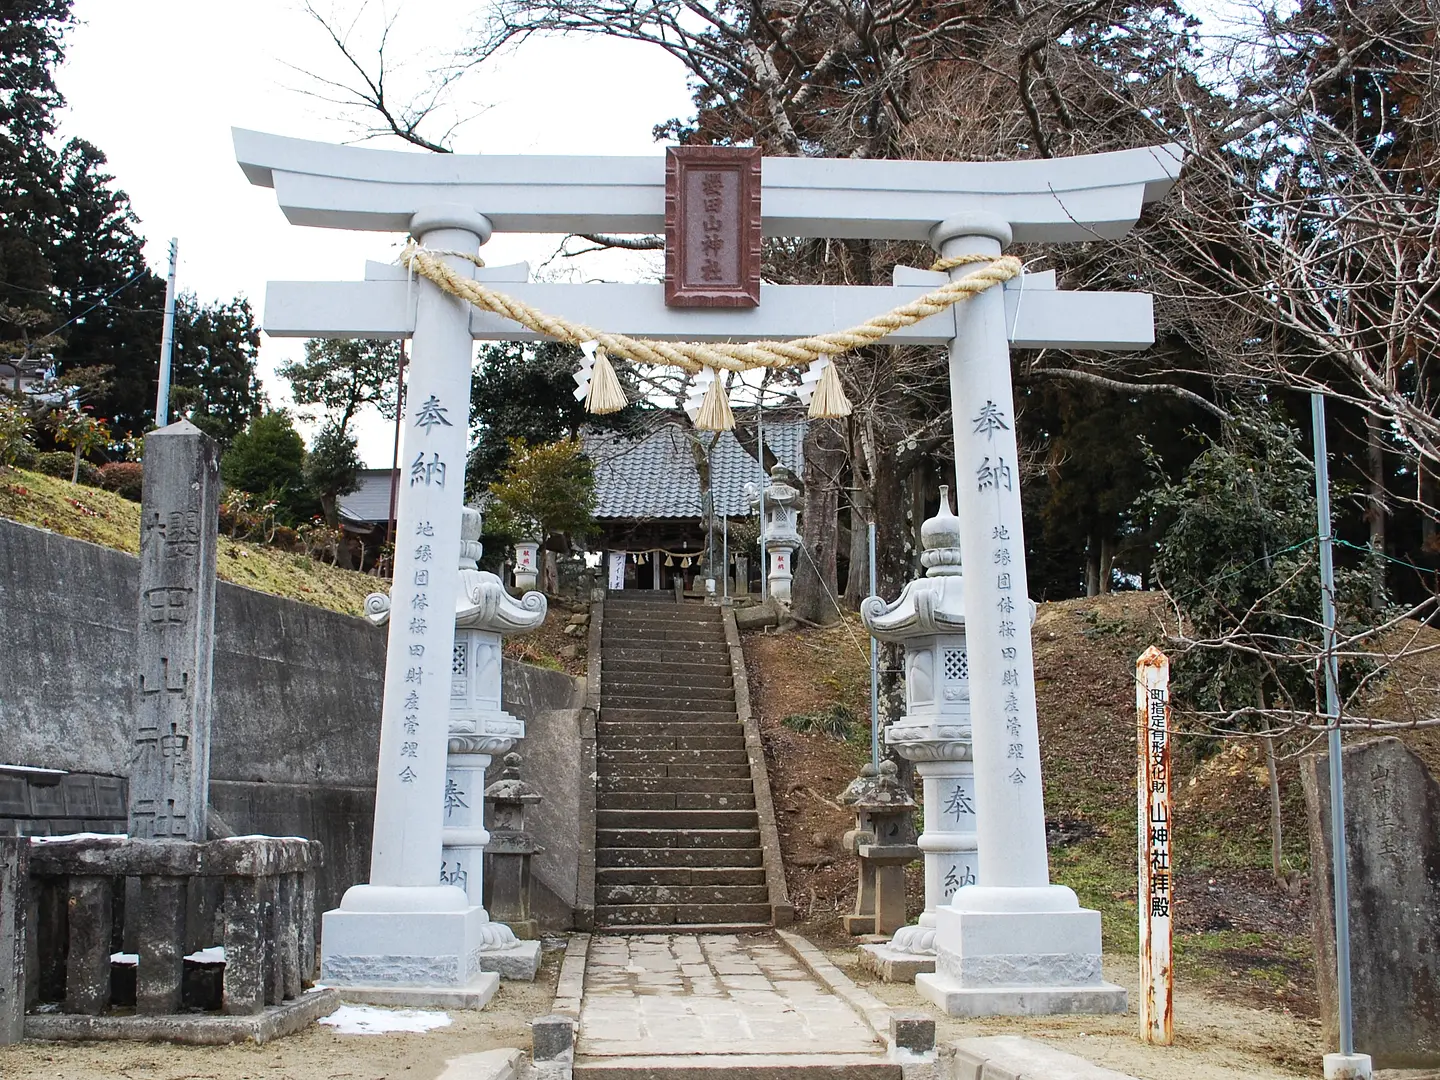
<box><xmin>130</xmin><ymin>420</ymin><xmax>220</xmax><ymax>842</ymax></box>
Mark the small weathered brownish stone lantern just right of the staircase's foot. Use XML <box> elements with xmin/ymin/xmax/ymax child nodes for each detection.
<box><xmin>841</xmin><ymin>762</ymin><xmax>920</xmax><ymax>936</ymax></box>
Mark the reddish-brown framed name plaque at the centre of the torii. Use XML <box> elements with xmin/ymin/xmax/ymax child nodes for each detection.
<box><xmin>665</xmin><ymin>147</ymin><xmax>760</xmax><ymax>308</ymax></box>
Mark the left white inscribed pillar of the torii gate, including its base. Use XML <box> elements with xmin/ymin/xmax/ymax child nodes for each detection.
<box><xmin>321</xmin><ymin>206</ymin><xmax>495</xmax><ymax>1008</ymax></box>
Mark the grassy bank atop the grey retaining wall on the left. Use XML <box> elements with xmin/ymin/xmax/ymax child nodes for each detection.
<box><xmin>0</xmin><ymin>469</ymin><xmax>383</xmax><ymax>615</ymax></box>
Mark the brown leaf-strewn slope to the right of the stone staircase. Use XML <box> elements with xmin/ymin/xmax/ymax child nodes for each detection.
<box><xmin>744</xmin><ymin>593</ymin><xmax>1440</xmax><ymax>1015</ymax></box>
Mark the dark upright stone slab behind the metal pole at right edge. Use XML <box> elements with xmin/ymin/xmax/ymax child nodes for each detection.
<box><xmin>1300</xmin><ymin>739</ymin><xmax>1440</xmax><ymax>1068</ymax></box>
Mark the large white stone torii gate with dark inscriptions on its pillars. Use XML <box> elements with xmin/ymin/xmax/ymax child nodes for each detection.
<box><xmin>235</xmin><ymin>130</ymin><xmax>1182</xmax><ymax>1014</ymax></box>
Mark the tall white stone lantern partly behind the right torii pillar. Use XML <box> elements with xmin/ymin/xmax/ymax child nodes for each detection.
<box><xmin>860</xmin><ymin>487</ymin><xmax>979</xmax><ymax>982</ymax></box>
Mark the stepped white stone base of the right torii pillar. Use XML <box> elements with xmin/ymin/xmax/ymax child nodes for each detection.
<box><xmin>914</xmin><ymin>886</ymin><xmax>1128</xmax><ymax>1017</ymax></box>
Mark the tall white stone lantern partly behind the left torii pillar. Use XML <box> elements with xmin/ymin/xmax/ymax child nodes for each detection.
<box><xmin>366</xmin><ymin>507</ymin><xmax>547</xmax><ymax>979</ymax></box>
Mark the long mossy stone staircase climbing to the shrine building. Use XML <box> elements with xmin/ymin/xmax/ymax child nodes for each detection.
<box><xmin>595</xmin><ymin>590</ymin><xmax>770</xmax><ymax>933</ymax></box>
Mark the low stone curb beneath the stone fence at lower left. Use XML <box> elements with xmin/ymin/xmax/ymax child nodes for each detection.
<box><xmin>24</xmin><ymin>989</ymin><xmax>340</xmax><ymax>1045</ymax></box>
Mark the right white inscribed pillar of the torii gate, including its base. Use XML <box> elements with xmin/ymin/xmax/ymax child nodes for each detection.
<box><xmin>916</xmin><ymin>215</ymin><xmax>1126</xmax><ymax>1015</ymax></box>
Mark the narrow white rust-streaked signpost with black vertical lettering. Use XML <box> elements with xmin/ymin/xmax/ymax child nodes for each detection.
<box><xmin>1135</xmin><ymin>645</ymin><xmax>1175</xmax><ymax>1047</ymax></box>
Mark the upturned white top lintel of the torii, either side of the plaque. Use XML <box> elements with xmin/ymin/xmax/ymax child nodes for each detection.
<box><xmin>233</xmin><ymin>128</ymin><xmax>1185</xmax><ymax>242</ymax></box>
